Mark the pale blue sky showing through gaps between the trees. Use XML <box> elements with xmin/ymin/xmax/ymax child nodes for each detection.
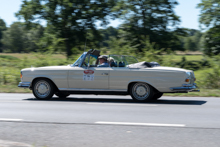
<box><xmin>0</xmin><ymin>0</ymin><xmax>201</xmax><ymax>30</ymax></box>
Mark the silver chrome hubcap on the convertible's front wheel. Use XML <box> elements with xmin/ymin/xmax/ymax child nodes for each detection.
<box><xmin>34</xmin><ymin>80</ymin><xmax>51</xmax><ymax>98</ymax></box>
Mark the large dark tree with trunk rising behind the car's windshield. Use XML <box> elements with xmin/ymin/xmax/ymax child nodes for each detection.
<box><xmin>17</xmin><ymin>0</ymin><xmax>116</xmax><ymax>57</ymax></box>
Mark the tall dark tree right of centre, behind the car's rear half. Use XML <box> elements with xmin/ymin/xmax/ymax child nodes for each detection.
<box><xmin>115</xmin><ymin>0</ymin><xmax>180</xmax><ymax>52</ymax></box>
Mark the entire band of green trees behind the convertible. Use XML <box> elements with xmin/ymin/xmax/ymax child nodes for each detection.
<box><xmin>0</xmin><ymin>0</ymin><xmax>220</xmax><ymax>57</ymax></box>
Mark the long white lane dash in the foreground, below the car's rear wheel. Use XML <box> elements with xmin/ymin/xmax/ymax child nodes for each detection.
<box><xmin>95</xmin><ymin>121</ymin><xmax>186</xmax><ymax>127</ymax></box>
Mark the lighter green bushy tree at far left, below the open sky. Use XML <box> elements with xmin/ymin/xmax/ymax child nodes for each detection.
<box><xmin>2</xmin><ymin>22</ymin><xmax>44</xmax><ymax>53</ymax></box>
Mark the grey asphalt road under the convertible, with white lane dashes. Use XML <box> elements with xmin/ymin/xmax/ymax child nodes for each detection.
<box><xmin>0</xmin><ymin>93</ymin><xmax>220</xmax><ymax>147</ymax></box>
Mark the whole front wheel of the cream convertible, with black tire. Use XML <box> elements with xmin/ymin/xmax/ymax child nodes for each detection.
<box><xmin>32</xmin><ymin>79</ymin><xmax>55</xmax><ymax>100</ymax></box>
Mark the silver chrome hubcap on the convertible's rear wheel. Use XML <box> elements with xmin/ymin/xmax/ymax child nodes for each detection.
<box><xmin>132</xmin><ymin>83</ymin><xmax>150</xmax><ymax>100</ymax></box>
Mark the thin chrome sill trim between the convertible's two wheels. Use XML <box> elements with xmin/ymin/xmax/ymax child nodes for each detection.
<box><xmin>59</xmin><ymin>88</ymin><xmax>127</xmax><ymax>92</ymax></box>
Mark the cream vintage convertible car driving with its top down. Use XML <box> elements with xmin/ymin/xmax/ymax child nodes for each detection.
<box><xmin>18</xmin><ymin>50</ymin><xmax>199</xmax><ymax>101</ymax></box>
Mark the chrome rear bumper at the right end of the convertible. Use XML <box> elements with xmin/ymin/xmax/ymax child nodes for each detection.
<box><xmin>170</xmin><ymin>83</ymin><xmax>200</xmax><ymax>92</ymax></box>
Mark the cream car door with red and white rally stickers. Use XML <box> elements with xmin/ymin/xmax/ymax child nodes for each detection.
<box><xmin>68</xmin><ymin>67</ymin><xmax>109</xmax><ymax>91</ymax></box>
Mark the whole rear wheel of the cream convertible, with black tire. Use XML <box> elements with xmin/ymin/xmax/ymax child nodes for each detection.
<box><xmin>129</xmin><ymin>82</ymin><xmax>154</xmax><ymax>102</ymax></box>
